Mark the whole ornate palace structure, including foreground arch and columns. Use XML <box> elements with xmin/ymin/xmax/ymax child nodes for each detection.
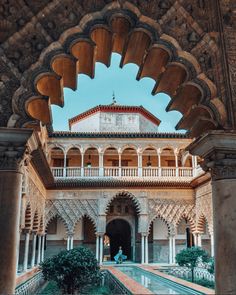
<box><xmin>0</xmin><ymin>0</ymin><xmax>236</xmax><ymax>295</ymax></box>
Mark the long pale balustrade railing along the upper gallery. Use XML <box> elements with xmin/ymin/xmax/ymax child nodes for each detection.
<box><xmin>51</xmin><ymin>167</ymin><xmax>199</xmax><ymax>180</ymax></box>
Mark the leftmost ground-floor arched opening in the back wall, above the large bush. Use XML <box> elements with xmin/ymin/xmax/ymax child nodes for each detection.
<box><xmin>45</xmin><ymin>216</ymin><xmax>67</xmax><ymax>258</ymax></box>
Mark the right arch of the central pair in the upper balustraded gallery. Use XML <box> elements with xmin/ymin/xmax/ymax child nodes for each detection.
<box><xmin>121</xmin><ymin>147</ymin><xmax>138</xmax><ymax>177</ymax></box>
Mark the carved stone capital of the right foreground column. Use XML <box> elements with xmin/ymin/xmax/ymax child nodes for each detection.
<box><xmin>187</xmin><ymin>130</ymin><xmax>236</xmax><ymax>180</ymax></box>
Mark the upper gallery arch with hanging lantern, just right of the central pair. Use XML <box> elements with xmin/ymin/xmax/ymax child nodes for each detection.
<box><xmin>142</xmin><ymin>147</ymin><xmax>159</xmax><ymax>177</ymax></box>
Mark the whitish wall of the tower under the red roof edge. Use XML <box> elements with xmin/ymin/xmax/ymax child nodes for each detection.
<box><xmin>71</xmin><ymin>112</ymin><xmax>158</xmax><ymax>132</ymax></box>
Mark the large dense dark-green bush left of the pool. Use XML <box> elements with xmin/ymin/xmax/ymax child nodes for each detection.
<box><xmin>41</xmin><ymin>247</ymin><xmax>100</xmax><ymax>294</ymax></box>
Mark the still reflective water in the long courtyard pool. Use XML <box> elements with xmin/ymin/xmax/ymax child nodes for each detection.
<box><xmin>118</xmin><ymin>266</ymin><xmax>203</xmax><ymax>295</ymax></box>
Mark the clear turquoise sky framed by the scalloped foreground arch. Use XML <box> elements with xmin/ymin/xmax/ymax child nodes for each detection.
<box><xmin>52</xmin><ymin>53</ymin><xmax>184</xmax><ymax>132</ymax></box>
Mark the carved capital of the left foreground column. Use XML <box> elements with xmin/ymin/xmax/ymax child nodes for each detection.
<box><xmin>0</xmin><ymin>128</ymin><xmax>38</xmax><ymax>172</ymax></box>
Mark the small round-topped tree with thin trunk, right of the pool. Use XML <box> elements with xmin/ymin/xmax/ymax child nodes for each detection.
<box><xmin>176</xmin><ymin>247</ymin><xmax>209</xmax><ymax>282</ymax></box>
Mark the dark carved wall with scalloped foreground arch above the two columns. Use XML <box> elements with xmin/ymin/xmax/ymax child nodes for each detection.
<box><xmin>0</xmin><ymin>0</ymin><xmax>236</xmax><ymax>136</ymax></box>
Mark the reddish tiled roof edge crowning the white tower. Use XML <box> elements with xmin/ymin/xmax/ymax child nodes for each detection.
<box><xmin>69</xmin><ymin>104</ymin><xmax>161</xmax><ymax>128</ymax></box>
